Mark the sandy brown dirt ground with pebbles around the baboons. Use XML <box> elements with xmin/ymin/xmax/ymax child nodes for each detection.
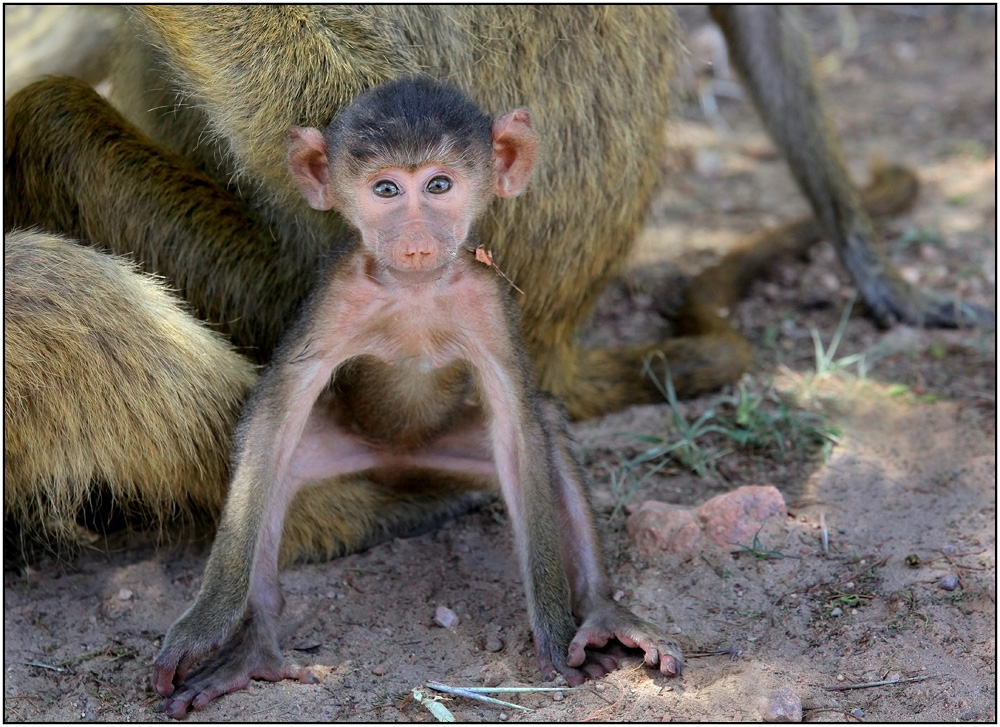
<box><xmin>4</xmin><ymin>6</ymin><xmax>997</xmax><ymax>722</ymax></box>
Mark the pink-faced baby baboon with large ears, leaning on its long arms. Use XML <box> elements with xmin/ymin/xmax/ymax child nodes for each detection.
<box><xmin>154</xmin><ymin>79</ymin><xmax>682</xmax><ymax>717</ymax></box>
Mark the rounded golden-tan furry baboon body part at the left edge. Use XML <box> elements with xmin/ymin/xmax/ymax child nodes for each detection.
<box><xmin>4</xmin><ymin>232</ymin><xmax>255</xmax><ymax>548</ymax></box>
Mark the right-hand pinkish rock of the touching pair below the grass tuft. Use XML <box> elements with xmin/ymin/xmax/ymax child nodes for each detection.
<box><xmin>700</xmin><ymin>485</ymin><xmax>788</xmax><ymax>547</ymax></box>
